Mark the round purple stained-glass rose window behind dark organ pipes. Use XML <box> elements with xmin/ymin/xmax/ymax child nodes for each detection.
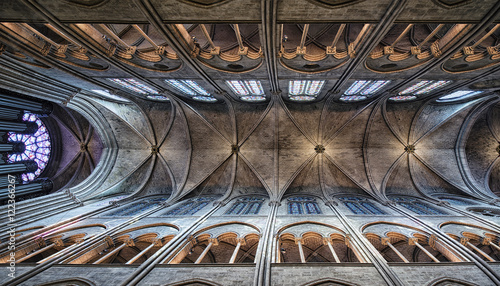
<box><xmin>7</xmin><ymin>113</ymin><xmax>51</xmax><ymax>182</ymax></box>
